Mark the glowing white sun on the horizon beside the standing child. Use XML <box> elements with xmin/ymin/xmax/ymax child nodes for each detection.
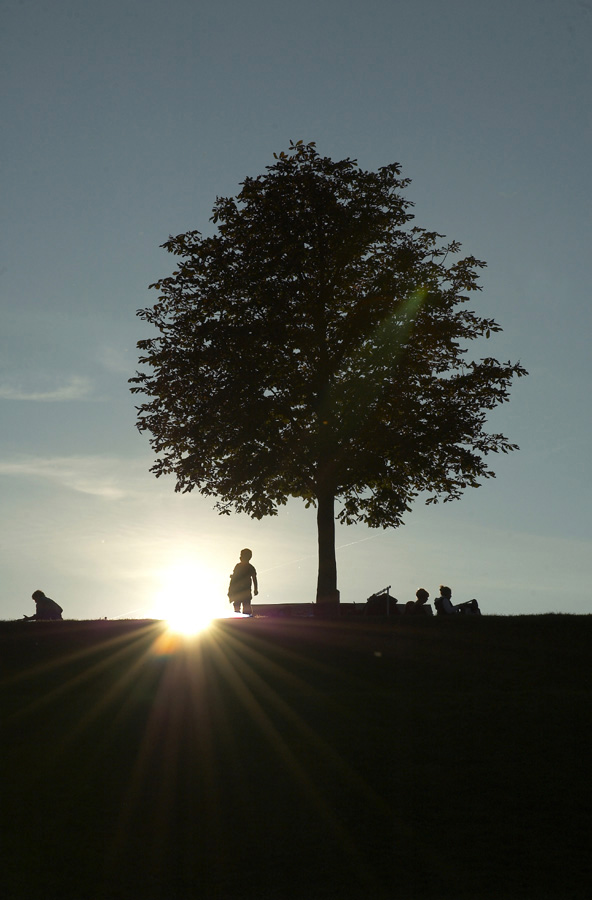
<box><xmin>153</xmin><ymin>560</ymin><xmax>229</xmax><ymax>637</ymax></box>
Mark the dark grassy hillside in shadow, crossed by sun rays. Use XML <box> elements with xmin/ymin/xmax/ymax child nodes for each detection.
<box><xmin>0</xmin><ymin>616</ymin><xmax>592</xmax><ymax>900</ymax></box>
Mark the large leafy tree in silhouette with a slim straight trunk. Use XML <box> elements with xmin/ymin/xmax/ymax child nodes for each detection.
<box><xmin>130</xmin><ymin>141</ymin><xmax>526</xmax><ymax>603</ymax></box>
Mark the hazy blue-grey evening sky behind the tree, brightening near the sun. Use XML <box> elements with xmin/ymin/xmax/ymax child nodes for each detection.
<box><xmin>0</xmin><ymin>0</ymin><xmax>592</xmax><ymax>619</ymax></box>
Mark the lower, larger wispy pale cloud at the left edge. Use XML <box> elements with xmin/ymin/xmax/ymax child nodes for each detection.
<box><xmin>0</xmin><ymin>456</ymin><xmax>132</xmax><ymax>500</ymax></box>
